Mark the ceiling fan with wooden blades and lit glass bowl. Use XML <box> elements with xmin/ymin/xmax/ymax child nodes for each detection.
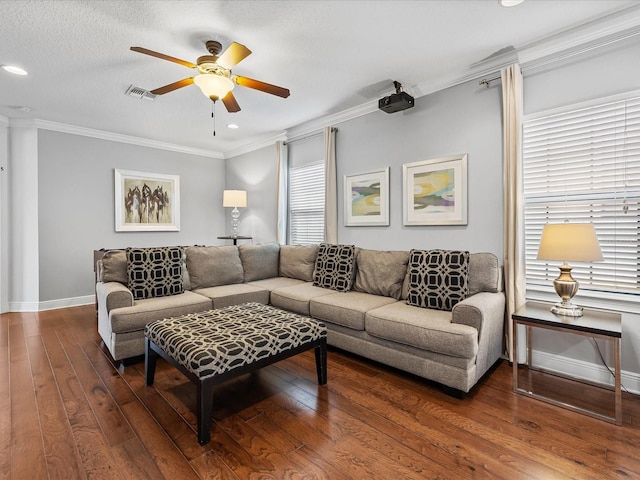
<box><xmin>131</xmin><ymin>40</ymin><xmax>289</xmax><ymax>112</ymax></box>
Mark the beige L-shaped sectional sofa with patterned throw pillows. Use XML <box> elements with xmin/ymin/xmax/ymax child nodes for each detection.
<box><xmin>96</xmin><ymin>243</ymin><xmax>505</xmax><ymax>392</ymax></box>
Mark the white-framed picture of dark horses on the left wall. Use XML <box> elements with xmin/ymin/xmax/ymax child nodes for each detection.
<box><xmin>114</xmin><ymin>168</ymin><xmax>180</xmax><ymax>232</ymax></box>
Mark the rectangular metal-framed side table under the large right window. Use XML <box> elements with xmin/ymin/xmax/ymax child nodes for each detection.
<box><xmin>511</xmin><ymin>302</ymin><xmax>622</xmax><ymax>425</ymax></box>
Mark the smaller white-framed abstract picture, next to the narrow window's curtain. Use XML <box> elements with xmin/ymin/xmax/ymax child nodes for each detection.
<box><xmin>343</xmin><ymin>167</ymin><xmax>389</xmax><ymax>227</ymax></box>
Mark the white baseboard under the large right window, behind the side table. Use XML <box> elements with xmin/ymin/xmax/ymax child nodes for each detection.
<box><xmin>532</xmin><ymin>350</ymin><xmax>640</xmax><ymax>394</ymax></box>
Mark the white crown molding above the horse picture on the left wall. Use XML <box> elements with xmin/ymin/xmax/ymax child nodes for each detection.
<box><xmin>9</xmin><ymin>118</ymin><xmax>225</xmax><ymax>160</ymax></box>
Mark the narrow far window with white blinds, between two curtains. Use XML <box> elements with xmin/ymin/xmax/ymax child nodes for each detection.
<box><xmin>289</xmin><ymin>161</ymin><xmax>324</xmax><ymax>245</ymax></box>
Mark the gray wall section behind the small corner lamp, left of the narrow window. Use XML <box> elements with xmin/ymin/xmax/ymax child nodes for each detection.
<box><xmin>225</xmin><ymin>144</ymin><xmax>278</xmax><ymax>243</ymax></box>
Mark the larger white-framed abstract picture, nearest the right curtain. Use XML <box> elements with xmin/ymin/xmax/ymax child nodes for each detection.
<box><xmin>402</xmin><ymin>153</ymin><xmax>467</xmax><ymax>225</ymax></box>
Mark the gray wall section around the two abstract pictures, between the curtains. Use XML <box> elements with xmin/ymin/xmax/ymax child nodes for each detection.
<box><xmin>336</xmin><ymin>78</ymin><xmax>502</xmax><ymax>258</ymax></box>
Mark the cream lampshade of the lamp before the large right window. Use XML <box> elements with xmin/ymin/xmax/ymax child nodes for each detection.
<box><xmin>538</xmin><ymin>223</ymin><xmax>603</xmax><ymax>262</ymax></box>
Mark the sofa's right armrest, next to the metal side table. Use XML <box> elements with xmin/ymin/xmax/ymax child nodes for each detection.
<box><xmin>451</xmin><ymin>292</ymin><xmax>505</xmax><ymax>380</ymax></box>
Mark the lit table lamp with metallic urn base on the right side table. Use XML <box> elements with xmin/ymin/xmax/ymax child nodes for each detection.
<box><xmin>538</xmin><ymin>223</ymin><xmax>603</xmax><ymax>317</ymax></box>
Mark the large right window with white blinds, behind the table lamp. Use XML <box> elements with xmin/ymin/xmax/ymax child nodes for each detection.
<box><xmin>523</xmin><ymin>92</ymin><xmax>640</xmax><ymax>295</ymax></box>
